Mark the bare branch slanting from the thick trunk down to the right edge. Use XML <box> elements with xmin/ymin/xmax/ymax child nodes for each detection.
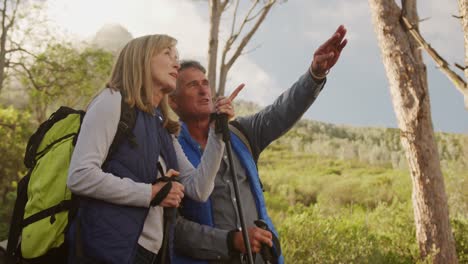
<box><xmin>402</xmin><ymin>16</ymin><xmax>468</xmax><ymax>94</ymax></box>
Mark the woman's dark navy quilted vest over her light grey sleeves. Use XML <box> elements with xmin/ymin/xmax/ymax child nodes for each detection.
<box><xmin>79</xmin><ymin>110</ymin><xmax>178</xmax><ymax>264</ymax></box>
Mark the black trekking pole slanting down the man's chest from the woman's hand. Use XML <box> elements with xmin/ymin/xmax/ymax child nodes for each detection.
<box><xmin>216</xmin><ymin>114</ymin><xmax>254</xmax><ymax>264</ymax></box>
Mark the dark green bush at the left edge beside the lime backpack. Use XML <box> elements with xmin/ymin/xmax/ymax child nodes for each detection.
<box><xmin>0</xmin><ymin>107</ymin><xmax>32</xmax><ymax>240</ymax></box>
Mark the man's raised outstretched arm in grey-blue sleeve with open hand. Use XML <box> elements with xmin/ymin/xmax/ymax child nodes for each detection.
<box><xmin>236</xmin><ymin>26</ymin><xmax>347</xmax><ymax>153</ymax></box>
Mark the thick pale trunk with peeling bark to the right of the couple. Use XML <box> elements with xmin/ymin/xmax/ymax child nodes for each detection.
<box><xmin>369</xmin><ymin>0</ymin><xmax>458</xmax><ymax>264</ymax></box>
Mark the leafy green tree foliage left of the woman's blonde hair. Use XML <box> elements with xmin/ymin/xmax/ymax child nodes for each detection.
<box><xmin>23</xmin><ymin>44</ymin><xmax>113</xmax><ymax>123</ymax></box>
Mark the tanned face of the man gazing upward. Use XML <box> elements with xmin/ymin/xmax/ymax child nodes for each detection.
<box><xmin>171</xmin><ymin>68</ymin><xmax>213</xmax><ymax>120</ymax></box>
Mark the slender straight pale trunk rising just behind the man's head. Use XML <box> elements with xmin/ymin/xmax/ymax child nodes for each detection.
<box><xmin>207</xmin><ymin>0</ymin><xmax>223</xmax><ymax>95</ymax></box>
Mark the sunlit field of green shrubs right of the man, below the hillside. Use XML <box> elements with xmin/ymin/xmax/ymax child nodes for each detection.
<box><xmin>259</xmin><ymin>135</ymin><xmax>468</xmax><ymax>263</ymax></box>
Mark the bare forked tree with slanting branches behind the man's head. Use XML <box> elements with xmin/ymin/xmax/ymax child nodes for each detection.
<box><xmin>208</xmin><ymin>0</ymin><xmax>278</xmax><ymax>95</ymax></box>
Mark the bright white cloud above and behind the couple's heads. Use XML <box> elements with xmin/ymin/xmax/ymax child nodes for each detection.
<box><xmin>48</xmin><ymin>0</ymin><xmax>278</xmax><ymax>104</ymax></box>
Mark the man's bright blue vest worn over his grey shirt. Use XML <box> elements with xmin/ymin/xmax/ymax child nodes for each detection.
<box><xmin>172</xmin><ymin>123</ymin><xmax>284</xmax><ymax>264</ymax></box>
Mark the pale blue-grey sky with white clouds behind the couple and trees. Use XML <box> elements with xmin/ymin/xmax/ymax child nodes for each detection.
<box><xmin>48</xmin><ymin>0</ymin><xmax>468</xmax><ymax>134</ymax></box>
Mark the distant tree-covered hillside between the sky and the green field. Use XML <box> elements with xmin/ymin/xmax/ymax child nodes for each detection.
<box><xmin>236</xmin><ymin>101</ymin><xmax>468</xmax><ymax>170</ymax></box>
